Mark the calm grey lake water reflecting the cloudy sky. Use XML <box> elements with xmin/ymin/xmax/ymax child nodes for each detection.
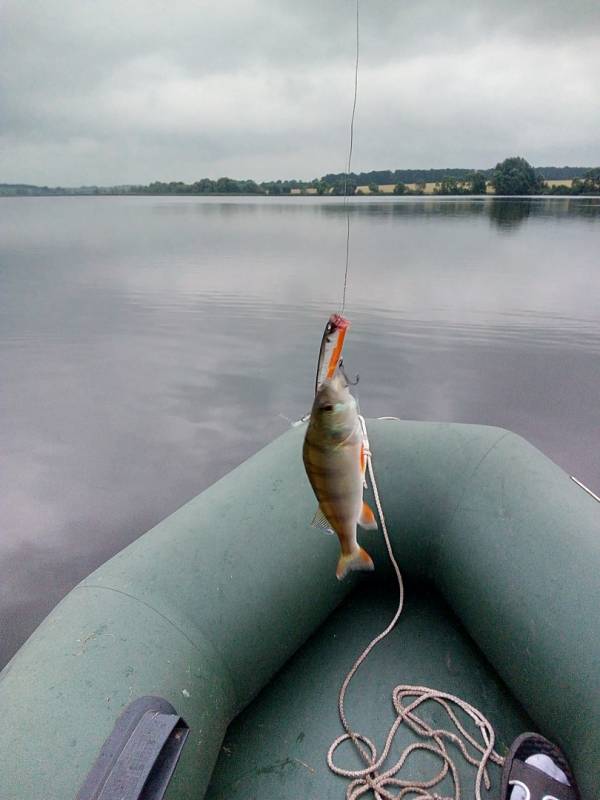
<box><xmin>0</xmin><ymin>197</ymin><xmax>600</xmax><ymax>664</ymax></box>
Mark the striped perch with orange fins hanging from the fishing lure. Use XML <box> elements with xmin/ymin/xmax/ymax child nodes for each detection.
<box><xmin>303</xmin><ymin>373</ymin><xmax>377</xmax><ymax>579</ymax></box>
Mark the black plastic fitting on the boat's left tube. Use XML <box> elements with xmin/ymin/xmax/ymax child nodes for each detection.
<box><xmin>76</xmin><ymin>696</ymin><xmax>190</xmax><ymax>800</ymax></box>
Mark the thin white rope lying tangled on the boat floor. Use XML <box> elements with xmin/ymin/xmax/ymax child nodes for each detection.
<box><xmin>327</xmin><ymin>416</ymin><xmax>504</xmax><ymax>800</ymax></box>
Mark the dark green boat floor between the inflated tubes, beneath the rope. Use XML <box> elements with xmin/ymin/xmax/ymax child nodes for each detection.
<box><xmin>206</xmin><ymin>578</ymin><xmax>535</xmax><ymax>800</ymax></box>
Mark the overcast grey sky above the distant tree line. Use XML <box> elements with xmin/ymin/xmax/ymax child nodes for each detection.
<box><xmin>0</xmin><ymin>0</ymin><xmax>600</xmax><ymax>185</ymax></box>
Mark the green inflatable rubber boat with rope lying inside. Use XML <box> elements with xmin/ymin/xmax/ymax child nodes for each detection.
<box><xmin>0</xmin><ymin>420</ymin><xmax>600</xmax><ymax>800</ymax></box>
